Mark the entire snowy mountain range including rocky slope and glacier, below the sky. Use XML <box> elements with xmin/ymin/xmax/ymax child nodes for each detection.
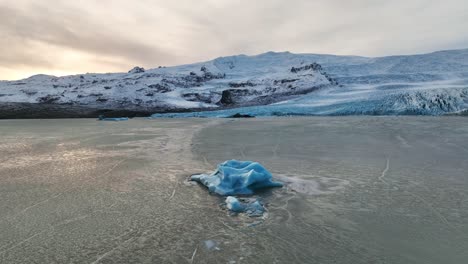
<box><xmin>0</xmin><ymin>49</ymin><xmax>468</xmax><ymax>116</ymax></box>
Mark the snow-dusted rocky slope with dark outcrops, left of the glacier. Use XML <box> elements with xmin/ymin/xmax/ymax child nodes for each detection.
<box><xmin>0</xmin><ymin>54</ymin><xmax>335</xmax><ymax>113</ymax></box>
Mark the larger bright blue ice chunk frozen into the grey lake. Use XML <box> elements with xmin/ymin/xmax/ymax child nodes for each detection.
<box><xmin>191</xmin><ymin>160</ymin><xmax>283</xmax><ymax>196</ymax></box>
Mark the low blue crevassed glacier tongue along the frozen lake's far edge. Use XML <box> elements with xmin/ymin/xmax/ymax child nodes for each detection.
<box><xmin>152</xmin><ymin>84</ymin><xmax>468</xmax><ymax>118</ymax></box>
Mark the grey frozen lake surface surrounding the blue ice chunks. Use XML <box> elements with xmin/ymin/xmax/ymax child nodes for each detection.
<box><xmin>0</xmin><ymin>117</ymin><xmax>468</xmax><ymax>263</ymax></box>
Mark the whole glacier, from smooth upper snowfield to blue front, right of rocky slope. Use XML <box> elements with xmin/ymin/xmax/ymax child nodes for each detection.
<box><xmin>153</xmin><ymin>49</ymin><xmax>468</xmax><ymax>118</ymax></box>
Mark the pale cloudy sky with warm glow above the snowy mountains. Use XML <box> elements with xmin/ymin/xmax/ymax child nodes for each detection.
<box><xmin>0</xmin><ymin>0</ymin><xmax>468</xmax><ymax>80</ymax></box>
